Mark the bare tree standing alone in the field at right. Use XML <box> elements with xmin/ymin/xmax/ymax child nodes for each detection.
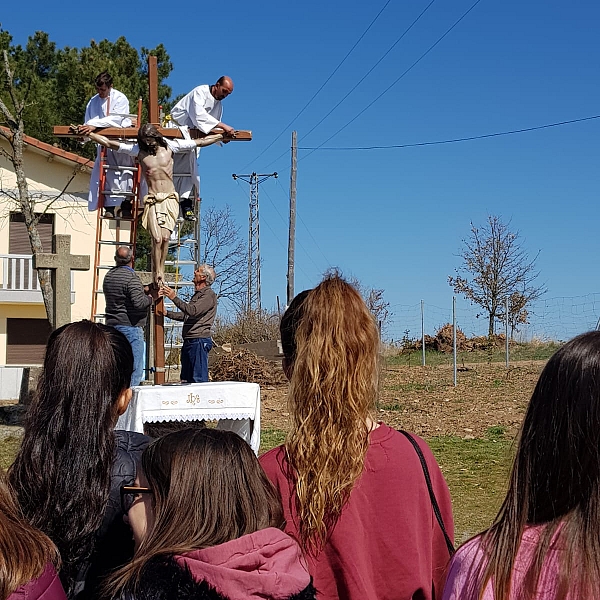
<box><xmin>448</xmin><ymin>216</ymin><xmax>546</xmax><ymax>336</ymax></box>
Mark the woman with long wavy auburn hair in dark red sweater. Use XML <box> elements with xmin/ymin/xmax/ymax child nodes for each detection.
<box><xmin>261</xmin><ymin>274</ymin><xmax>453</xmax><ymax>600</ymax></box>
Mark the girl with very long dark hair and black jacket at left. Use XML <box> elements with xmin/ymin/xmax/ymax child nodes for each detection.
<box><xmin>9</xmin><ymin>321</ymin><xmax>149</xmax><ymax>599</ymax></box>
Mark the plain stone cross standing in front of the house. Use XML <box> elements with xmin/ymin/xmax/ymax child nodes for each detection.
<box><xmin>33</xmin><ymin>234</ymin><xmax>90</xmax><ymax>329</ymax></box>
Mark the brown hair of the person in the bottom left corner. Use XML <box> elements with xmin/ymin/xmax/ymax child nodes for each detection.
<box><xmin>0</xmin><ymin>470</ymin><xmax>60</xmax><ymax>600</ymax></box>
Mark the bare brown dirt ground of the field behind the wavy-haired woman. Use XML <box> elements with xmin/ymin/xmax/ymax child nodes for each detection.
<box><xmin>261</xmin><ymin>361</ymin><xmax>545</xmax><ymax>439</ymax></box>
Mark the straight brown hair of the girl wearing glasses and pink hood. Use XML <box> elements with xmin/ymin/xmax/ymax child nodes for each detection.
<box><xmin>105</xmin><ymin>429</ymin><xmax>283</xmax><ymax>597</ymax></box>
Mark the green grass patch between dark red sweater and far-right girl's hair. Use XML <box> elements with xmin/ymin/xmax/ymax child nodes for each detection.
<box><xmin>427</xmin><ymin>426</ymin><xmax>513</xmax><ymax>543</ymax></box>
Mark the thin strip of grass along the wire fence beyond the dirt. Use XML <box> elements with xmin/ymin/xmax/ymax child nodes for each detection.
<box><xmin>386</xmin><ymin>342</ymin><xmax>561</xmax><ymax>367</ymax></box>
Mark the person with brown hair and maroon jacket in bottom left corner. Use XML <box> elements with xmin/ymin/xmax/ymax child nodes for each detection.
<box><xmin>0</xmin><ymin>471</ymin><xmax>67</xmax><ymax>600</ymax></box>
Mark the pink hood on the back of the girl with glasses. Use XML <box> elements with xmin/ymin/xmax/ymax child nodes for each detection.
<box><xmin>176</xmin><ymin>527</ymin><xmax>310</xmax><ymax>600</ymax></box>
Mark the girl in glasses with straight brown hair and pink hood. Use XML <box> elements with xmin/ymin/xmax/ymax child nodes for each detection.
<box><xmin>104</xmin><ymin>429</ymin><xmax>315</xmax><ymax>600</ymax></box>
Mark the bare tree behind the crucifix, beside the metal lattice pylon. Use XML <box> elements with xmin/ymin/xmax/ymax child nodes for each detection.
<box><xmin>201</xmin><ymin>204</ymin><xmax>248</xmax><ymax>310</ymax></box>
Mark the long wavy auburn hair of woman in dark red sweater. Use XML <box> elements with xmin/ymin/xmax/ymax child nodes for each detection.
<box><xmin>281</xmin><ymin>273</ymin><xmax>379</xmax><ymax>551</ymax></box>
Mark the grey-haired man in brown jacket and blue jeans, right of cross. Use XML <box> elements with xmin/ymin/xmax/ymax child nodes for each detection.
<box><xmin>159</xmin><ymin>265</ymin><xmax>217</xmax><ymax>383</ymax></box>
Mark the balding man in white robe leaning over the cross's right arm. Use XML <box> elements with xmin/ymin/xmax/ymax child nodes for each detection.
<box><xmin>171</xmin><ymin>75</ymin><xmax>235</xmax><ymax>220</ymax></box>
